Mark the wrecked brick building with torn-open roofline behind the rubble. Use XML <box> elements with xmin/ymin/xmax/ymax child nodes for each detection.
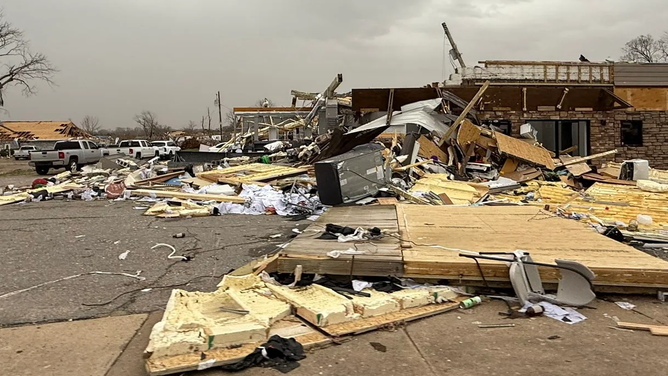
<box><xmin>353</xmin><ymin>61</ymin><xmax>668</xmax><ymax>168</ymax></box>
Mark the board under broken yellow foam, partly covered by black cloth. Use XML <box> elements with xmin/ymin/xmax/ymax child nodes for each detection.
<box><xmin>146</xmin><ymin>317</ymin><xmax>332</xmax><ymax>376</ymax></box>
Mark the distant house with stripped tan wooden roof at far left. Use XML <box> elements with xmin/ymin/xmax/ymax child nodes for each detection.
<box><xmin>0</xmin><ymin>121</ymin><xmax>90</xmax><ymax>149</ymax></box>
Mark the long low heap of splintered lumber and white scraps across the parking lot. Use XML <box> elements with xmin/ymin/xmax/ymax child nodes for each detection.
<box><xmin>0</xmin><ymin>158</ymin><xmax>323</xmax><ymax>218</ymax></box>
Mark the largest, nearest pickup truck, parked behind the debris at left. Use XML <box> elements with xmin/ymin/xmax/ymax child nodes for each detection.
<box><xmin>29</xmin><ymin>140</ymin><xmax>102</xmax><ymax>175</ymax></box>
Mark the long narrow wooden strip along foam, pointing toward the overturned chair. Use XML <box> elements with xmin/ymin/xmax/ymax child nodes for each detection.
<box><xmin>322</xmin><ymin>298</ymin><xmax>464</xmax><ymax>337</ymax></box>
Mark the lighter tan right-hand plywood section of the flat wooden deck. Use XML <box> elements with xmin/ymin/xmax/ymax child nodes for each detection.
<box><xmin>401</xmin><ymin>205</ymin><xmax>668</xmax><ymax>287</ymax></box>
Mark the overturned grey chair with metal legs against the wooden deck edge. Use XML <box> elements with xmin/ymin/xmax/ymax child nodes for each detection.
<box><xmin>459</xmin><ymin>250</ymin><xmax>596</xmax><ymax>307</ymax></box>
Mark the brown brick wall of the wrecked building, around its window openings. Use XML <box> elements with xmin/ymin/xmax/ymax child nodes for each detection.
<box><xmin>479</xmin><ymin>110</ymin><xmax>668</xmax><ymax>169</ymax></box>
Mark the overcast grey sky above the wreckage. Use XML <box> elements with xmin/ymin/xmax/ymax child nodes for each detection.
<box><xmin>0</xmin><ymin>0</ymin><xmax>668</xmax><ymax>129</ymax></box>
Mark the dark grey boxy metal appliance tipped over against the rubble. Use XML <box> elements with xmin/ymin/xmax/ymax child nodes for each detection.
<box><xmin>315</xmin><ymin>144</ymin><xmax>387</xmax><ymax>205</ymax></box>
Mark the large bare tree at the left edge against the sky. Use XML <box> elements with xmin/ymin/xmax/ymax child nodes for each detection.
<box><xmin>0</xmin><ymin>12</ymin><xmax>58</xmax><ymax>106</ymax></box>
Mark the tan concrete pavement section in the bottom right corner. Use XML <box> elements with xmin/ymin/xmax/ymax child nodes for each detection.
<box><xmin>406</xmin><ymin>300</ymin><xmax>668</xmax><ymax>376</ymax></box>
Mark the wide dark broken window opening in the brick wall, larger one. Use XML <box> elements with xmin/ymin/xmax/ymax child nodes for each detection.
<box><xmin>528</xmin><ymin>120</ymin><xmax>589</xmax><ymax>157</ymax></box>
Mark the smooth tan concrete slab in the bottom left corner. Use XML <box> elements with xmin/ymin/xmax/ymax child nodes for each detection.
<box><xmin>0</xmin><ymin>314</ymin><xmax>147</xmax><ymax>376</ymax></box>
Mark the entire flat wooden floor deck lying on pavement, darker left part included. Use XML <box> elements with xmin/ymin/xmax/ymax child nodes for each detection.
<box><xmin>278</xmin><ymin>204</ymin><xmax>668</xmax><ymax>288</ymax></box>
